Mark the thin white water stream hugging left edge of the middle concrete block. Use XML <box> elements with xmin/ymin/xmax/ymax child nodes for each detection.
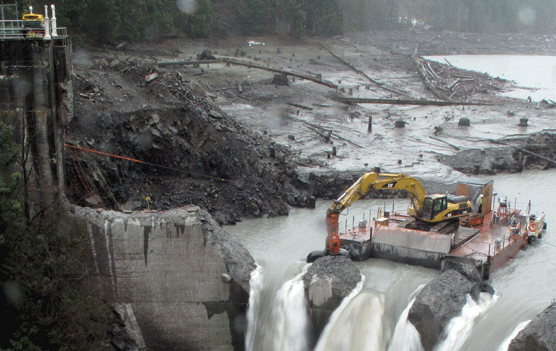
<box><xmin>388</xmin><ymin>284</ymin><xmax>425</xmax><ymax>351</ymax></box>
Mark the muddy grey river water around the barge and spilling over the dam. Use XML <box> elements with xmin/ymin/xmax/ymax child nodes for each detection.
<box><xmin>226</xmin><ymin>170</ymin><xmax>556</xmax><ymax>351</ymax></box>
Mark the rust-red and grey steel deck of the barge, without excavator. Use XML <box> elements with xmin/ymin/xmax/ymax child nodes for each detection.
<box><xmin>340</xmin><ymin>209</ymin><xmax>527</xmax><ymax>276</ymax></box>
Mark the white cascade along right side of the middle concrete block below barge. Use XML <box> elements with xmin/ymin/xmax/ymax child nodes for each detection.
<box><xmin>434</xmin><ymin>293</ymin><xmax>498</xmax><ymax>351</ymax></box>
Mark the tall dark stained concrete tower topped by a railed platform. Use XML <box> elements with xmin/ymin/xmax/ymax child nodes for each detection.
<box><xmin>0</xmin><ymin>29</ymin><xmax>73</xmax><ymax>212</ymax></box>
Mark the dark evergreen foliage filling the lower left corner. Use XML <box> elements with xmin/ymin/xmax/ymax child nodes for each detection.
<box><xmin>0</xmin><ymin>122</ymin><xmax>112</xmax><ymax>351</ymax></box>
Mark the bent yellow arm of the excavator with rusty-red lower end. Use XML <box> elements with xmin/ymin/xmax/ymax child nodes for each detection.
<box><xmin>326</xmin><ymin>172</ymin><xmax>427</xmax><ymax>254</ymax></box>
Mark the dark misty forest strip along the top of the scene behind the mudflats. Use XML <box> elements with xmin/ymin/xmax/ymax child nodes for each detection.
<box><xmin>6</xmin><ymin>0</ymin><xmax>556</xmax><ymax>44</ymax></box>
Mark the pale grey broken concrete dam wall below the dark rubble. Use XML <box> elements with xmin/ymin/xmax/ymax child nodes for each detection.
<box><xmin>75</xmin><ymin>206</ymin><xmax>255</xmax><ymax>350</ymax></box>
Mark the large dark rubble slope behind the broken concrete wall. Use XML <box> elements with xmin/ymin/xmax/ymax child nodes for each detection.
<box><xmin>66</xmin><ymin>55</ymin><xmax>315</xmax><ymax>224</ymax></box>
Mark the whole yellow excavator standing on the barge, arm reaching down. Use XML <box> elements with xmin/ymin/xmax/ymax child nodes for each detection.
<box><xmin>325</xmin><ymin>172</ymin><xmax>471</xmax><ymax>255</ymax></box>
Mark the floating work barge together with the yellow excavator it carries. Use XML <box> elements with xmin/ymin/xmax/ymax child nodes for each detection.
<box><xmin>308</xmin><ymin>174</ymin><xmax>546</xmax><ymax>280</ymax></box>
